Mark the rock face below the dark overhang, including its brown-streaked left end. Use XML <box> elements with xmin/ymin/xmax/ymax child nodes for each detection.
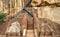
<box><xmin>27</xmin><ymin>6</ymin><xmax>60</xmax><ymax>24</ymax></box>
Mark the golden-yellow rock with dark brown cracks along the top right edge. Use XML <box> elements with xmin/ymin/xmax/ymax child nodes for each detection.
<box><xmin>31</xmin><ymin>0</ymin><xmax>60</xmax><ymax>7</ymax></box>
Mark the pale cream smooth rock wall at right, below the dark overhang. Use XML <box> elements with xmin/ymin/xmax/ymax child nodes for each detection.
<box><xmin>38</xmin><ymin>6</ymin><xmax>60</xmax><ymax>24</ymax></box>
